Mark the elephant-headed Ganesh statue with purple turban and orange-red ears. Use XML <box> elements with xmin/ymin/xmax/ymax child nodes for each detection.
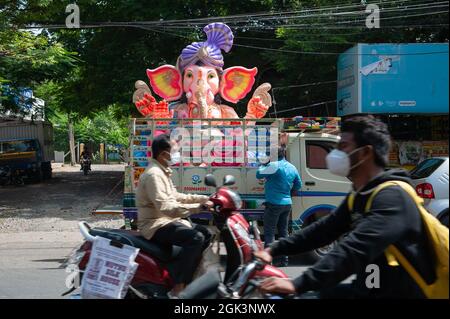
<box><xmin>133</xmin><ymin>23</ymin><xmax>272</xmax><ymax>124</ymax></box>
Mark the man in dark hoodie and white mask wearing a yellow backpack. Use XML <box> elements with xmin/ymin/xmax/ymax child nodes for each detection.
<box><xmin>255</xmin><ymin>116</ymin><xmax>448</xmax><ymax>298</ymax></box>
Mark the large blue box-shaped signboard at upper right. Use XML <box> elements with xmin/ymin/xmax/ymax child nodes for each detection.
<box><xmin>337</xmin><ymin>43</ymin><xmax>449</xmax><ymax>116</ymax></box>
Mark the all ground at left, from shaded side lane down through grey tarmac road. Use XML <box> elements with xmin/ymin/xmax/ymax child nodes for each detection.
<box><xmin>0</xmin><ymin>166</ymin><xmax>316</xmax><ymax>299</ymax></box>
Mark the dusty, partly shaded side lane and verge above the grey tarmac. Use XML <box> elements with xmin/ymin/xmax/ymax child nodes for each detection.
<box><xmin>0</xmin><ymin>165</ymin><xmax>124</xmax><ymax>233</ymax></box>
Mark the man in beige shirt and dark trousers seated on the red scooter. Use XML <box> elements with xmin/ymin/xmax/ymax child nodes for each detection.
<box><xmin>136</xmin><ymin>134</ymin><xmax>213</xmax><ymax>296</ymax></box>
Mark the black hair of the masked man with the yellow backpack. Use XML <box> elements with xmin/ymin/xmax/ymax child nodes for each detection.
<box><xmin>341</xmin><ymin>115</ymin><xmax>391</xmax><ymax>167</ymax></box>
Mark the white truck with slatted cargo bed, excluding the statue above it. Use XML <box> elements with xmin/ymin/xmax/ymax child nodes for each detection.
<box><xmin>125</xmin><ymin>117</ymin><xmax>351</xmax><ymax>255</ymax></box>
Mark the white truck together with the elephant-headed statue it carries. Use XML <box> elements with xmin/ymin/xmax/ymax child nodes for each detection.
<box><xmin>117</xmin><ymin>23</ymin><xmax>350</xmax><ymax>258</ymax></box>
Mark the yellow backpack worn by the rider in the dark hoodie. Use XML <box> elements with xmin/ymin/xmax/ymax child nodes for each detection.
<box><xmin>348</xmin><ymin>181</ymin><xmax>449</xmax><ymax>299</ymax></box>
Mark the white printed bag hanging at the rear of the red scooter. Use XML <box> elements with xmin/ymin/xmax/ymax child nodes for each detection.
<box><xmin>81</xmin><ymin>236</ymin><xmax>139</xmax><ymax>299</ymax></box>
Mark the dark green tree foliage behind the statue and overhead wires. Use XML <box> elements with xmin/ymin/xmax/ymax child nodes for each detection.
<box><xmin>0</xmin><ymin>0</ymin><xmax>448</xmax><ymax>119</ymax></box>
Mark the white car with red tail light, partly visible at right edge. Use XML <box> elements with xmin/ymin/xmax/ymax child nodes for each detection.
<box><xmin>411</xmin><ymin>157</ymin><xmax>449</xmax><ymax>227</ymax></box>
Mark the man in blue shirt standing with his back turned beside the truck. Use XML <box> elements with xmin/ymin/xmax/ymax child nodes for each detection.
<box><xmin>256</xmin><ymin>147</ymin><xmax>302</xmax><ymax>266</ymax></box>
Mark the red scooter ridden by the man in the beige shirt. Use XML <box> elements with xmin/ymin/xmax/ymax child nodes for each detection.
<box><xmin>63</xmin><ymin>174</ymin><xmax>288</xmax><ymax>299</ymax></box>
